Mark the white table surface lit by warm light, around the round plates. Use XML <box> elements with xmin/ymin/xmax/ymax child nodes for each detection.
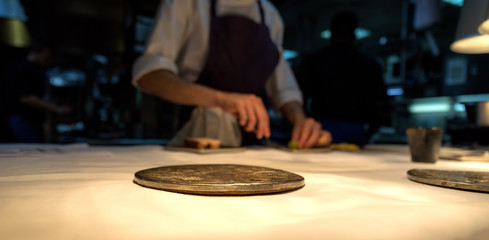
<box><xmin>0</xmin><ymin>144</ymin><xmax>489</xmax><ymax>240</ymax></box>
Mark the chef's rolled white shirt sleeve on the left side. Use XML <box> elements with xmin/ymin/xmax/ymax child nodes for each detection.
<box><xmin>132</xmin><ymin>0</ymin><xmax>193</xmax><ymax>86</ymax></box>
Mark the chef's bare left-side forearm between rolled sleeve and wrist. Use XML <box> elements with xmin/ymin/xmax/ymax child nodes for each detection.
<box><xmin>139</xmin><ymin>70</ymin><xmax>223</xmax><ymax>106</ymax></box>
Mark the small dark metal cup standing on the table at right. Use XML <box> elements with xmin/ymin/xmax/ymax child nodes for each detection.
<box><xmin>406</xmin><ymin>128</ymin><xmax>443</xmax><ymax>163</ymax></box>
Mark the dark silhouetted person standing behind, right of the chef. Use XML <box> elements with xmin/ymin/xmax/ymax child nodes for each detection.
<box><xmin>297</xmin><ymin>11</ymin><xmax>389</xmax><ymax>146</ymax></box>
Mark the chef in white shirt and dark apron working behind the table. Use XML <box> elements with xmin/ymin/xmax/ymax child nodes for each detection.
<box><xmin>133</xmin><ymin>0</ymin><xmax>331</xmax><ymax>148</ymax></box>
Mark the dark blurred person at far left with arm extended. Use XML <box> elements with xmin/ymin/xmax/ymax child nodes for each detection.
<box><xmin>6</xmin><ymin>44</ymin><xmax>71</xmax><ymax>143</ymax></box>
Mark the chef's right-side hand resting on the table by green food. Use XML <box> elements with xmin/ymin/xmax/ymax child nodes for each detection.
<box><xmin>291</xmin><ymin>118</ymin><xmax>332</xmax><ymax>148</ymax></box>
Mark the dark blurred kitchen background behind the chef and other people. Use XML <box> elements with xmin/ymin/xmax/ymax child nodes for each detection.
<box><xmin>0</xmin><ymin>0</ymin><xmax>489</xmax><ymax>143</ymax></box>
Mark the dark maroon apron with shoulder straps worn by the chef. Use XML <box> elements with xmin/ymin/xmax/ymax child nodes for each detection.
<box><xmin>187</xmin><ymin>0</ymin><xmax>279</xmax><ymax>145</ymax></box>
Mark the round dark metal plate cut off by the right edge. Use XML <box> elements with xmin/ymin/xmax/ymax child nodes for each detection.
<box><xmin>407</xmin><ymin>169</ymin><xmax>489</xmax><ymax>192</ymax></box>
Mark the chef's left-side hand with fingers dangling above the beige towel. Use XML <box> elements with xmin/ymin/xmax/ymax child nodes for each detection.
<box><xmin>221</xmin><ymin>93</ymin><xmax>270</xmax><ymax>139</ymax></box>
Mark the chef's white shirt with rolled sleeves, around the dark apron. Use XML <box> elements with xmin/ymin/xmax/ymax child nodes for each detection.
<box><xmin>132</xmin><ymin>0</ymin><xmax>302</xmax><ymax>109</ymax></box>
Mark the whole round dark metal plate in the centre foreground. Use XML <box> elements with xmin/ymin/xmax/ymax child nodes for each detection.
<box><xmin>134</xmin><ymin>164</ymin><xmax>305</xmax><ymax>195</ymax></box>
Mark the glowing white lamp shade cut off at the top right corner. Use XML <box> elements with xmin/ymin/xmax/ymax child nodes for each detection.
<box><xmin>450</xmin><ymin>0</ymin><xmax>489</xmax><ymax>54</ymax></box>
